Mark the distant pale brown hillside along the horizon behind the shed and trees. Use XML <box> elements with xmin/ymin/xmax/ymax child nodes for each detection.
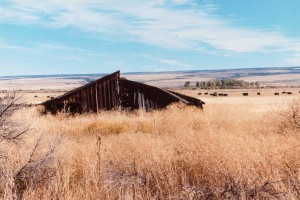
<box><xmin>0</xmin><ymin>67</ymin><xmax>300</xmax><ymax>90</ymax></box>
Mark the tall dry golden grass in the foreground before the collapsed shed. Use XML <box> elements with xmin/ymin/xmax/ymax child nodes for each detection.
<box><xmin>5</xmin><ymin>97</ymin><xmax>300</xmax><ymax>199</ymax></box>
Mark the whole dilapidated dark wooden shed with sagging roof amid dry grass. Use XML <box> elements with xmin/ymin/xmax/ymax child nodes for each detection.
<box><xmin>41</xmin><ymin>71</ymin><xmax>204</xmax><ymax>114</ymax></box>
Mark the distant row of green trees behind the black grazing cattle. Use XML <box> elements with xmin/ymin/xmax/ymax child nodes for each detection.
<box><xmin>184</xmin><ymin>79</ymin><xmax>260</xmax><ymax>89</ymax></box>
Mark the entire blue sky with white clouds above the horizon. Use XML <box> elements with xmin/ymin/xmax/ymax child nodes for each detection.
<box><xmin>0</xmin><ymin>0</ymin><xmax>300</xmax><ymax>76</ymax></box>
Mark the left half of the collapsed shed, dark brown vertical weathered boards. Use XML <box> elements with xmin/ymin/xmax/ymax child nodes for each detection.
<box><xmin>42</xmin><ymin>71</ymin><xmax>120</xmax><ymax>113</ymax></box>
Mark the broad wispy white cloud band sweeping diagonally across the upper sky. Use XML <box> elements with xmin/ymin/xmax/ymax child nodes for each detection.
<box><xmin>0</xmin><ymin>0</ymin><xmax>300</xmax><ymax>57</ymax></box>
